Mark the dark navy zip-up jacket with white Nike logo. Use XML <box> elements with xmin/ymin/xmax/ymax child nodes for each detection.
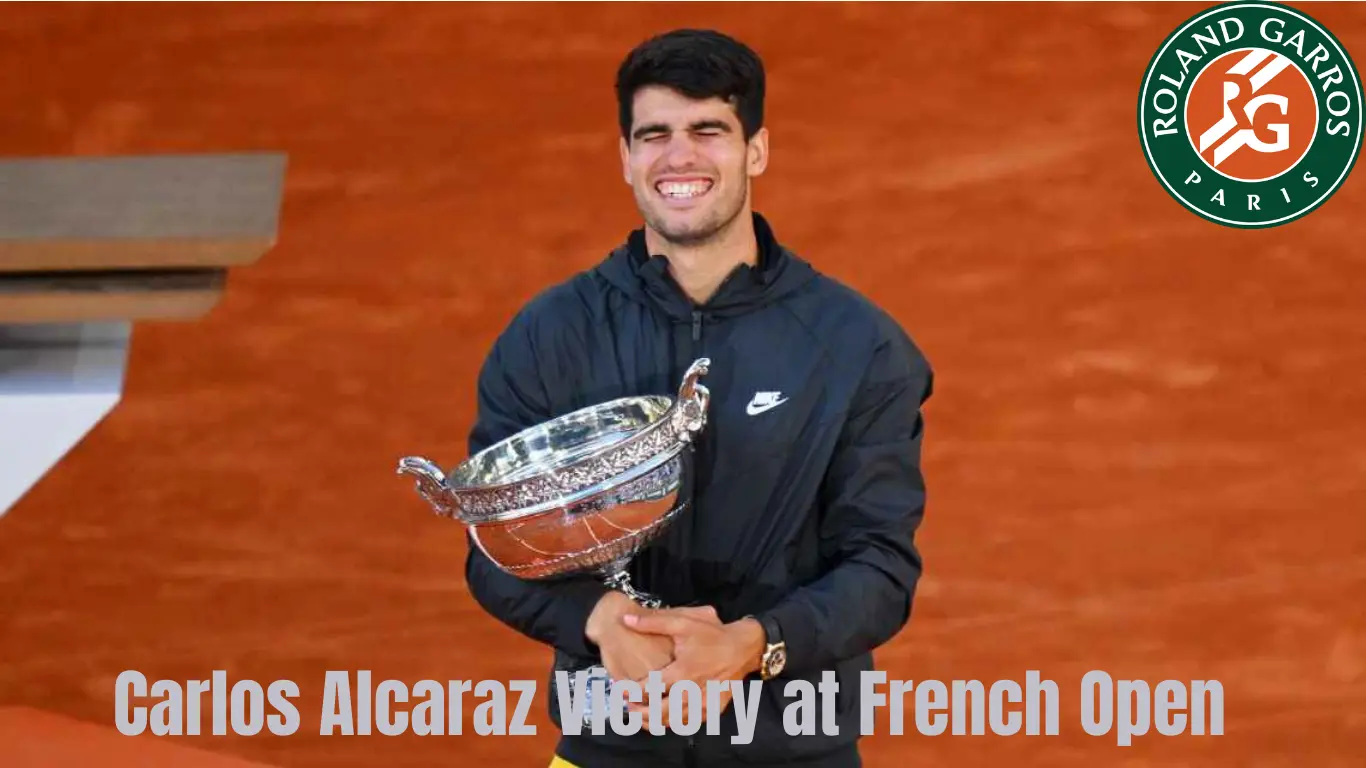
<box><xmin>466</xmin><ymin>215</ymin><xmax>933</xmax><ymax>765</ymax></box>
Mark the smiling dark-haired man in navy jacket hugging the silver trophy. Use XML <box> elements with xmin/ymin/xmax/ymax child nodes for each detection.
<box><xmin>466</xmin><ymin>30</ymin><xmax>932</xmax><ymax>768</ymax></box>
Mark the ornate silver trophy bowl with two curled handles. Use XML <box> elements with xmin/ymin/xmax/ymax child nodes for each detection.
<box><xmin>398</xmin><ymin>358</ymin><xmax>710</xmax><ymax>607</ymax></box>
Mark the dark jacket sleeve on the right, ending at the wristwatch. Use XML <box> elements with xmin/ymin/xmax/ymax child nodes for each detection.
<box><xmin>765</xmin><ymin>325</ymin><xmax>933</xmax><ymax>674</ymax></box>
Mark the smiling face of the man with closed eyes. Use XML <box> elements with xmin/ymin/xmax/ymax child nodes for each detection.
<box><xmin>622</xmin><ymin>86</ymin><xmax>768</xmax><ymax>245</ymax></box>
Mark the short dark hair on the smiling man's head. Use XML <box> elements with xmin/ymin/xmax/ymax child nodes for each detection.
<box><xmin>616</xmin><ymin>29</ymin><xmax>765</xmax><ymax>139</ymax></box>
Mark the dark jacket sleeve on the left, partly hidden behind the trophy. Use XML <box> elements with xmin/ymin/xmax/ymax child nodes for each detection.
<box><xmin>464</xmin><ymin>316</ymin><xmax>608</xmax><ymax>657</ymax></box>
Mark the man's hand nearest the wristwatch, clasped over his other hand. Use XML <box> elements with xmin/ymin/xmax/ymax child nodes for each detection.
<box><xmin>622</xmin><ymin>608</ymin><xmax>764</xmax><ymax>728</ymax></box>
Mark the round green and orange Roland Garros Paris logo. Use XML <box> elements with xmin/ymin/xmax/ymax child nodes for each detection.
<box><xmin>1138</xmin><ymin>3</ymin><xmax>1362</xmax><ymax>227</ymax></box>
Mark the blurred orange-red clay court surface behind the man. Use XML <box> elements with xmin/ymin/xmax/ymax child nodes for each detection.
<box><xmin>0</xmin><ymin>4</ymin><xmax>1366</xmax><ymax>768</ymax></box>
